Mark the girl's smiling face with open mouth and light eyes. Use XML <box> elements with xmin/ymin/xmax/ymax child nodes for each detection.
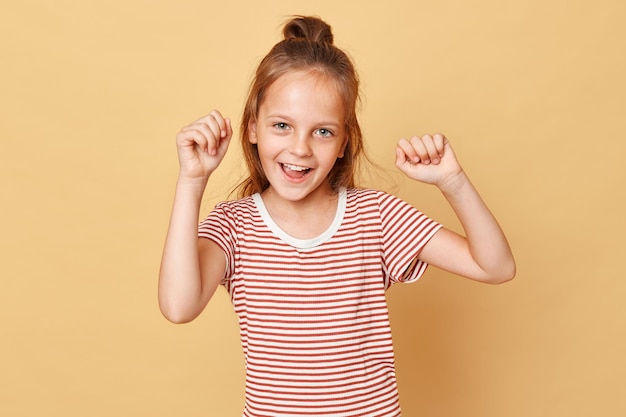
<box><xmin>250</xmin><ymin>71</ymin><xmax>346</xmax><ymax>206</ymax></box>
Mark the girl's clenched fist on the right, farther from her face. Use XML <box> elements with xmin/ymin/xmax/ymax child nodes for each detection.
<box><xmin>396</xmin><ymin>133</ymin><xmax>463</xmax><ymax>188</ymax></box>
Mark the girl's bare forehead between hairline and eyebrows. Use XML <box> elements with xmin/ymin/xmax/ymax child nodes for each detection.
<box><xmin>259</xmin><ymin>71</ymin><xmax>344</xmax><ymax>121</ymax></box>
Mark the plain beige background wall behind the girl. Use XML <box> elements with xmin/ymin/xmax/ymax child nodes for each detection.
<box><xmin>0</xmin><ymin>0</ymin><xmax>626</xmax><ymax>417</ymax></box>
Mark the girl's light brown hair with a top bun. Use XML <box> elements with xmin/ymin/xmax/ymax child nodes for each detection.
<box><xmin>237</xmin><ymin>16</ymin><xmax>363</xmax><ymax>197</ymax></box>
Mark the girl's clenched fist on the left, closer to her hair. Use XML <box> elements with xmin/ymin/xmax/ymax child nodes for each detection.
<box><xmin>176</xmin><ymin>110</ymin><xmax>233</xmax><ymax>181</ymax></box>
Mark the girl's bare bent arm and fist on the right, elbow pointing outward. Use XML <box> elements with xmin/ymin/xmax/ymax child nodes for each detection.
<box><xmin>396</xmin><ymin>134</ymin><xmax>515</xmax><ymax>284</ymax></box>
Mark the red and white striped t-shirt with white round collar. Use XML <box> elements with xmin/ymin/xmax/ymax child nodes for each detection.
<box><xmin>199</xmin><ymin>189</ymin><xmax>440</xmax><ymax>417</ymax></box>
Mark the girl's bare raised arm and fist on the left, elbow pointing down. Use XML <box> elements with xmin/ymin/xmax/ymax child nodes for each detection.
<box><xmin>159</xmin><ymin>110</ymin><xmax>232</xmax><ymax>323</ymax></box>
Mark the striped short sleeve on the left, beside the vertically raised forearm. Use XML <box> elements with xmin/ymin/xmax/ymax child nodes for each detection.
<box><xmin>198</xmin><ymin>204</ymin><xmax>237</xmax><ymax>290</ymax></box>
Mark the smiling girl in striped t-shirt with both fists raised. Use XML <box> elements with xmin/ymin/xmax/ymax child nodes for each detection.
<box><xmin>159</xmin><ymin>17</ymin><xmax>515</xmax><ymax>417</ymax></box>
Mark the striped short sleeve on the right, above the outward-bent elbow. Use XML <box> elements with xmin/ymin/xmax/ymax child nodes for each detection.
<box><xmin>379</xmin><ymin>193</ymin><xmax>442</xmax><ymax>285</ymax></box>
